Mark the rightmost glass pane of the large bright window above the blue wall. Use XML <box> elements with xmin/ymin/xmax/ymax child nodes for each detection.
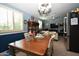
<box><xmin>14</xmin><ymin>11</ymin><xmax>23</xmax><ymax>30</ymax></box>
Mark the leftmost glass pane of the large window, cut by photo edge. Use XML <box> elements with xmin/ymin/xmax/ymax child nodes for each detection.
<box><xmin>0</xmin><ymin>7</ymin><xmax>7</xmax><ymax>30</ymax></box>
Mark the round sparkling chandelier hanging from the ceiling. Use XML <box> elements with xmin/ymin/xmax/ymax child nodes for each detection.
<box><xmin>38</xmin><ymin>3</ymin><xmax>51</xmax><ymax>16</ymax></box>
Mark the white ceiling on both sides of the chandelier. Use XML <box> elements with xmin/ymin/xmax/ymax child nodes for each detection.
<box><xmin>1</xmin><ymin>3</ymin><xmax>79</xmax><ymax>18</ymax></box>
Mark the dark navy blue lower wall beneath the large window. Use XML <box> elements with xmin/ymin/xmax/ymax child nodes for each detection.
<box><xmin>0</xmin><ymin>33</ymin><xmax>24</xmax><ymax>52</ymax></box>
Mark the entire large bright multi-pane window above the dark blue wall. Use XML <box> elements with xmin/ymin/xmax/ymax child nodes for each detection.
<box><xmin>0</xmin><ymin>6</ymin><xmax>23</xmax><ymax>32</ymax></box>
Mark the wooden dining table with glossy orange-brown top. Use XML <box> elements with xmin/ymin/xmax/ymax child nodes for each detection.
<box><xmin>9</xmin><ymin>35</ymin><xmax>51</xmax><ymax>56</ymax></box>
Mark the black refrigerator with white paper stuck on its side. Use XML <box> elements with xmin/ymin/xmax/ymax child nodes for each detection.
<box><xmin>64</xmin><ymin>12</ymin><xmax>79</xmax><ymax>52</ymax></box>
